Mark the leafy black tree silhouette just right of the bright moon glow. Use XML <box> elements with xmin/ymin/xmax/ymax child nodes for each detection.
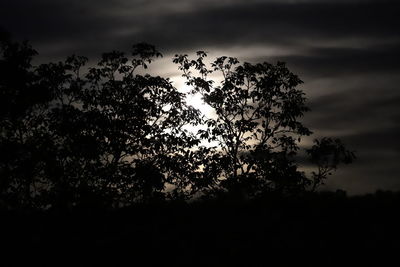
<box><xmin>174</xmin><ymin>51</ymin><xmax>354</xmax><ymax>199</ymax></box>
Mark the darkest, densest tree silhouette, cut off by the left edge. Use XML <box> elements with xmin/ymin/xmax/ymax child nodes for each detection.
<box><xmin>0</xmin><ymin>29</ymin><xmax>51</xmax><ymax>207</ymax></box>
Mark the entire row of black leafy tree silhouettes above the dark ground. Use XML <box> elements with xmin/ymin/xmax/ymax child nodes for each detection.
<box><xmin>0</xmin><ymin>34</ymin><xmax>354</xmax><ymax>208</ymax></box>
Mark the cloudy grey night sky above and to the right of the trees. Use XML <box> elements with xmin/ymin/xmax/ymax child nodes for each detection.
<box><xmin>0</xmin><ymin>0</ymin><xmax>400</xmax><ymax>194</ymax></box>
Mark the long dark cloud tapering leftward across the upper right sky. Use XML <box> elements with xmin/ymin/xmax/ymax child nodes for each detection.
<box><xmin>142</xmin><ymin>2</ymin><xmax>400</xmax><ymax>47</ymax></box>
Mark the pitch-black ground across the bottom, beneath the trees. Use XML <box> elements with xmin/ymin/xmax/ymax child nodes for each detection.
<box><xmin>1</xmin><ymin>192</ymin><xmax>400</xmax><ymax>266</ymax></box>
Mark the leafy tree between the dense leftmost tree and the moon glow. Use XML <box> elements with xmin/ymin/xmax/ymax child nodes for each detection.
<box><xmin>38</xmin><ymin>44</ymin><xmax>205</xmax><ymax>208</ymax></box>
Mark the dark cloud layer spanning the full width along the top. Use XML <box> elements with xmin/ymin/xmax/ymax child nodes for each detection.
<box><xmin>0</xmin><ymin>0</ymin><xmax>400</xmax><ymax>58</ymax></box>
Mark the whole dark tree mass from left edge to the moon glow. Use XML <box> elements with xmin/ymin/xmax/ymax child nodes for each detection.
<box><xmin>0</xmin><ymin>34</ymin><xmax>205</xmax><ymax>207</ymax></box>
